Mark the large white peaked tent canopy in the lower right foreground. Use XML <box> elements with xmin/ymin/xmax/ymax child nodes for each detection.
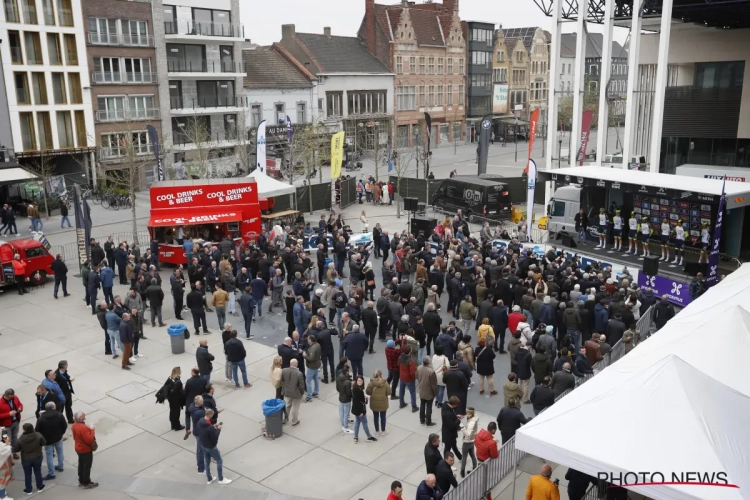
<box><xmin>516</xmin><ymin>265</ymin><xmax>750</xmax><ymax>500</ymax></box>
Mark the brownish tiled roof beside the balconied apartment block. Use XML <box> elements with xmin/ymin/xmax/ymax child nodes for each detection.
<box><xmin>242</xmin><ymin>47</ymin><xmax>312</xmax><ymax>88</ymax></box>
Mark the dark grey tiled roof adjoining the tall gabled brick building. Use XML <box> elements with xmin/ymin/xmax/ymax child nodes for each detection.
<box><xmin>295</xmin><ymin>33</ymin><xmax>390</xmax><ymax>73</ymax></box>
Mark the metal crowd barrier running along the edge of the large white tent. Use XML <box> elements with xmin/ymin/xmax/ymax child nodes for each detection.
<box><xmin>443</xmin><ymin>307</ymin><xmax>653</xmax><ymax>500</ymax></box>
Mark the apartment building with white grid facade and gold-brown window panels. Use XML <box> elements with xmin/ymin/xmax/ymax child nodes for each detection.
<box><xmin>0</xmin><ymin>0</ymin><xmax>95</xmax><ymax>176</ymax></box>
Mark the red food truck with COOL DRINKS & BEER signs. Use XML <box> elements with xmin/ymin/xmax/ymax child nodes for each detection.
<box><xmin>148</xmin><ymin>179</ymin><xmax>267</xmax><ymax>265</ymax></box>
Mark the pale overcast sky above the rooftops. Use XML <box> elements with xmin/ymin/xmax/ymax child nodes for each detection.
<box><xmin>240</xmin><ymin>0</ymin><xmax>627</xmax><ymax>45</ymax></box>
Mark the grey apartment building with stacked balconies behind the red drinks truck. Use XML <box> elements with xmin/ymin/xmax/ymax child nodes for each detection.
<box><xmin>152</xmin><ymin>0</ymin><xmax>249</xmax><ymax>176</ymax></box>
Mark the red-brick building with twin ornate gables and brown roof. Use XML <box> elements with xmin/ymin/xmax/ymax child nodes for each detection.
<box><xmin>358</xmin><ymin>0</ymin><xmax>466</xmax><ymax>148</ymax></box>
